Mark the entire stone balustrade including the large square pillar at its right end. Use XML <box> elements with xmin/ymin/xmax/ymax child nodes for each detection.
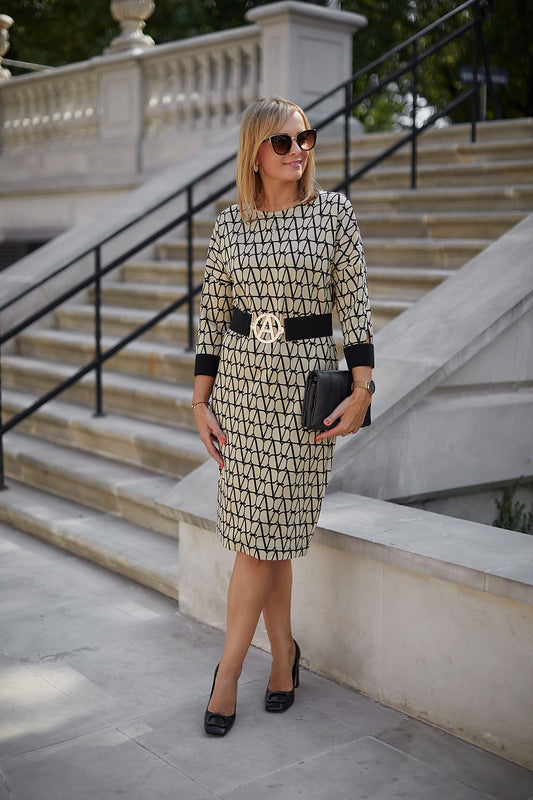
<box><xmin>0</xmin><ymin>0</ymin><xmax>366</xmax><ymax>186</ymax></box>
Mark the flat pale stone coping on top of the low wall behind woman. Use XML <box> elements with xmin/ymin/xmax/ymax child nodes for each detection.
<box><xmin>157</xmin><ymin>462</ymin><xmax>533</xmax><ymax>605</ymax></box>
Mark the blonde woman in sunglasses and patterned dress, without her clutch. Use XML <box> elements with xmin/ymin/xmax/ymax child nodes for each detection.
<box><xmin>192</xmin><ymin>98</ymin><xmax>373</xmax><ymax>735</ymax></box>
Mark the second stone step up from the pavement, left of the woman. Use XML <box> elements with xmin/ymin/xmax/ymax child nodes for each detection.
<box><xmin>0</xmin><ymin>431</ymin><xmax>178</xmax><ymax>538</ymax></box>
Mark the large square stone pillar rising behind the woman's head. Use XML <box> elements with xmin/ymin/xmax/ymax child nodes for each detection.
<box><xmin>246</xmin><ymin>0</ymin><xmax>367</xmax><ymax>121</ymax></box>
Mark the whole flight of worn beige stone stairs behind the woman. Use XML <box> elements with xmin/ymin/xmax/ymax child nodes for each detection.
<box><xmin>0</xmin><ymin>120</ymin><xmax>533</xmax><ymax>597</ymax></box>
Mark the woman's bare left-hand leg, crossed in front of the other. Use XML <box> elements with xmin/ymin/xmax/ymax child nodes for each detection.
<box><xmin>209</xmin><ymin>552</ymin><xmax>276</xmax><ymax>715</ymax></box>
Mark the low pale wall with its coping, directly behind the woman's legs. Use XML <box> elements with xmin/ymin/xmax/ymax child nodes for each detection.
<box><xmin>157</xmin><ymin>463</ymin><xmax>533</xmax><ymax>768</ymax></box>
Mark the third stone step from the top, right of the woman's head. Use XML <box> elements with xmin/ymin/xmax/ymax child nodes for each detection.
<box><xmin>317</xmin><ymin>160</ymin><xmax>533</xmax><ymax>191</ymax></box>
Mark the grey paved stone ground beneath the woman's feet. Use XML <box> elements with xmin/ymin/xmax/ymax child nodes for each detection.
<box><xmin>0</xmin><ymin>525</ymin><xmax>533</xmax><ymax>800</ymax></box>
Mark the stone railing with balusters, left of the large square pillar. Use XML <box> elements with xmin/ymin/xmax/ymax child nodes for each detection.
<box><xmin>0</xmin><ymin>26</ymin><xmax>259</xmax><ymax>167</ymax></box>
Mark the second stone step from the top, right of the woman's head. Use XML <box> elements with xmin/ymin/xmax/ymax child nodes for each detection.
<box><xmin>316</xmin><ymin>137</ymin><xmax>533</xmax><ymax>174</ymax></box>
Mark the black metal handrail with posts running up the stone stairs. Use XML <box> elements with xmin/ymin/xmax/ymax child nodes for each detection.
<box><xmin>0</xmin><ymin>0</ymin><xmax>497</xmax><ymax>489</ymax></box>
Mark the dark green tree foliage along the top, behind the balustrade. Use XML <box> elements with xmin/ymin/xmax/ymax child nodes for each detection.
<box><xmin>2</xmin><ymin>0</ymin><xmax>533</xmax><ymax>130</ymax></box>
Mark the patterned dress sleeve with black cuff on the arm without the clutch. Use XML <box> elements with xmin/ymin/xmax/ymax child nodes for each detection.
<box><xmin>194</xmin><ymin>211</ymin><xmax>233</xmax><ymax>377</ymax></box>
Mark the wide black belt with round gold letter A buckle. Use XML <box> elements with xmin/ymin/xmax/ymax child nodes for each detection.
<box><xmin>230</xmin><ymin>308</ymin><xmax>333</xmax><ymax>343</ymax></box>
